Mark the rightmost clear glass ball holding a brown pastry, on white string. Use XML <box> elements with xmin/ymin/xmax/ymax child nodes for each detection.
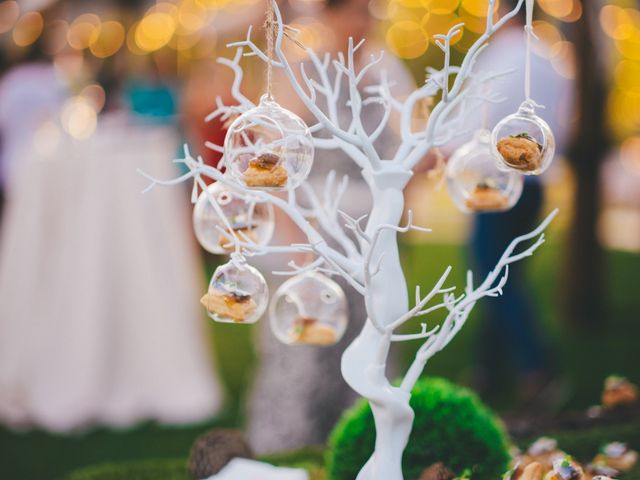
<box><xmin>491</xmin><ymin>101</ymin><xmax>556</xmax><ymax>175</ymax></box>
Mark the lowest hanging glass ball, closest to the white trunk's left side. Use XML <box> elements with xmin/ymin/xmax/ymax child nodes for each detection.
<box><xmin>269</xmin><ymin>272</ymin><xmax>349</xmax><ymax>346</ymax></box>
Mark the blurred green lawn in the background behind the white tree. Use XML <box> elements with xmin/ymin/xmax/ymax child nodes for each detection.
<box><xmin>0</xmin><ymin>246</ymin><xmax>640</xmax><ymax>480</ymax></box>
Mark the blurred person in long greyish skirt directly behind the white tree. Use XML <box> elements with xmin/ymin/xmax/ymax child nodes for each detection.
<box><xmin>248</xmin><ymin>0</ymin><xmax>414</xmax><ymax>452</ymax></box>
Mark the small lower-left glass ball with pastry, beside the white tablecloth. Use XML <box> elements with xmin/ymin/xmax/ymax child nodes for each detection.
<box><xmin>200</xmin><ymin>261</ymin><xmax>269</xmax><ymax>323</ymax></box>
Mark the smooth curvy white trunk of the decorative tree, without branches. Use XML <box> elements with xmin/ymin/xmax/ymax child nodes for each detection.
<box><xmin>341</xmin><ymin>166</ymin><xmax>414</xmax><ymax>480</ymax></box>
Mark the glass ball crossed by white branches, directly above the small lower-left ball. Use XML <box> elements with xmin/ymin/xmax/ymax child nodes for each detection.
<box><xmin>193</xmin><ymin>182</ymin><xmax>275</xmax><ymax>255</ymax></box>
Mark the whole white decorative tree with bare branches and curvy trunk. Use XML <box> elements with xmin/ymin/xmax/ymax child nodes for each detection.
<box><xmin>141</xmin><ymin>0</ymin><xmax>557</xmax><ymax>480</ymax></box>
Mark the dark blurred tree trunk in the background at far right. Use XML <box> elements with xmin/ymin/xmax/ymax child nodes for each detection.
<box><xmin>563</xmin><ymin>2</ymin><xmax>609</xmax><ymax>330</ymax></box>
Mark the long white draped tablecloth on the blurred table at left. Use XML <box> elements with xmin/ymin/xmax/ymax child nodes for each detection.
<box><xmin>0</xmin><ymin>111</ymin><xmax>221</xmax><ymax>431</ymax></box>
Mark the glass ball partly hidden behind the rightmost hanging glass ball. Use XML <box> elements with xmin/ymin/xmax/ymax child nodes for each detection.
<box><xmin>446</xmin><ymin>130</ymin><xmax>524</xmax><ymax>213</ymax></box>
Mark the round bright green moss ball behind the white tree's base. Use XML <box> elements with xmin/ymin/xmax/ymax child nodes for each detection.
<box><xmin>327</xmin><ymin>378</ymin><xmax>509</xmax><ymax>480</ymax></box>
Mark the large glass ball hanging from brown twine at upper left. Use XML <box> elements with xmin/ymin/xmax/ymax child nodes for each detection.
<box><xmin>224</xmin><ymin>95</ymin><xmax>313</xmax><ymax>190</ymax></box>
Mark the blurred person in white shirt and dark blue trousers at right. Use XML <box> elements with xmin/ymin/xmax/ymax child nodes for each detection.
<box><xmin>460</xmin><ymin>2</ymin><xmax>573</xmax><ymax>403</ymax></box>
